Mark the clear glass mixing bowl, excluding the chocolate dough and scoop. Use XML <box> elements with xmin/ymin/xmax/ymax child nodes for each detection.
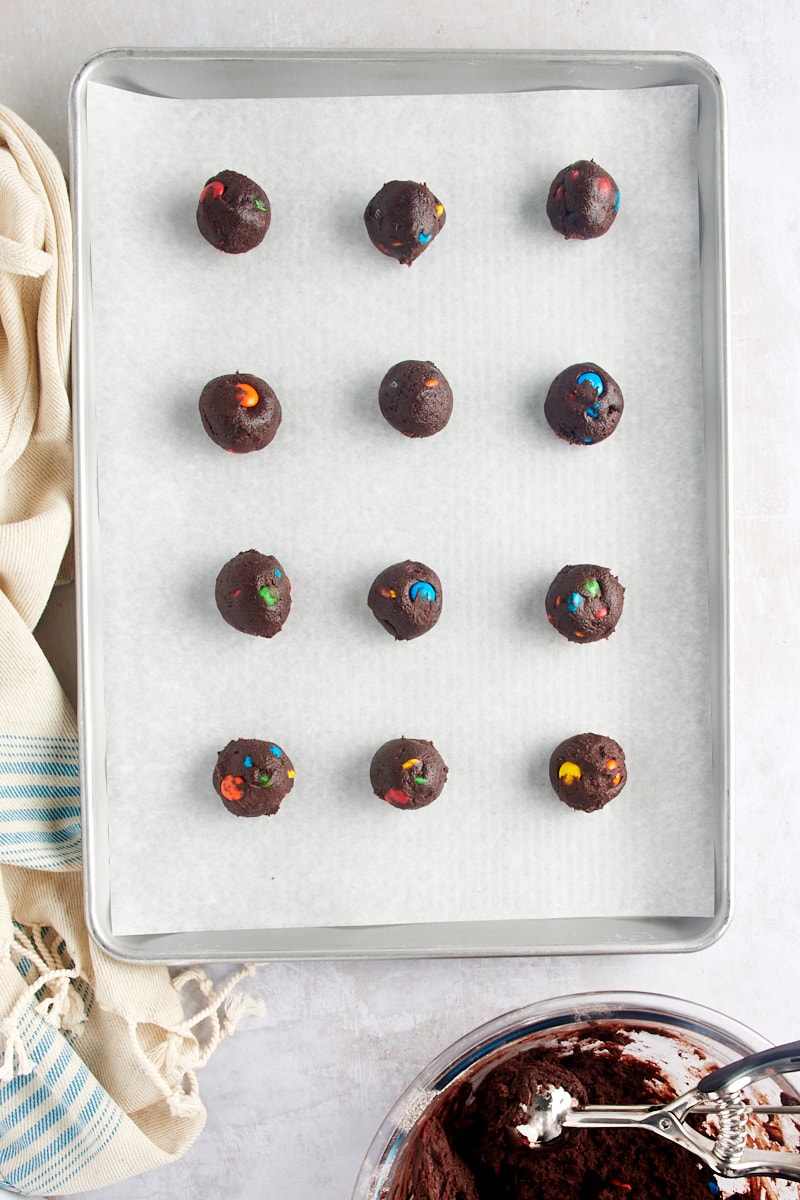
<box><xmin>353</xmin><ymin>991</ymin><xmax>800</xmax><ymax>1200</ymax></box>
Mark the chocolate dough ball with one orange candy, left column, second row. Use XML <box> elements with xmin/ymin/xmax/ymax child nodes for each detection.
<box><xmin>200</xmin><ymin>371</ymin><xmax>282</xmax><ymax>454</ymax></box>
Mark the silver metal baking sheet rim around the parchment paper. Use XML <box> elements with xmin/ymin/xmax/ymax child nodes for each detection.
<box><xmin>70</xmin><ymin>49</ymin><xmax>733</xmax><ymax>964</ymax></box>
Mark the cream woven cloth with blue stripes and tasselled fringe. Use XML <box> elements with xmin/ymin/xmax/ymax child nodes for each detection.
<box><xmin>0</xmin><ymin>107</ymin><xmax>260</xmax><ymax>1195</ymax></box>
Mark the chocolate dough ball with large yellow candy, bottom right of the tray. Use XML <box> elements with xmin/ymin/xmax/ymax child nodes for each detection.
<box><xmin>549</xmin><ymin>733</ymin><xmax>627</xmax><ymax>812</ymax></box>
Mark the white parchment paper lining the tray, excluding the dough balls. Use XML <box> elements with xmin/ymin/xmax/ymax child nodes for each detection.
<box><xmin>89</xmin><ymin>84</ymin><xmax>721</xmax><ymax>935</ymax></box>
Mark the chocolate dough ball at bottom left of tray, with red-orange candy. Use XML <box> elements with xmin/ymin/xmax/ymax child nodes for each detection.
<box><xmin>213</xmin><ymin>738</ymin><xmax>294</xmax><ymax>817</ymax></box>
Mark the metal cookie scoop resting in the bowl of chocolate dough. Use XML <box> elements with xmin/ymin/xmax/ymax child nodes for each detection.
<box><xmin>517</xmin><ymin>1042</ymin><xmax>800</xmax><ymax>1181</ymax></box>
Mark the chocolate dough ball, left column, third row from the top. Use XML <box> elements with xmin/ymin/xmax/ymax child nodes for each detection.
<box><xmin>215</xmin><ymin>550</ymin><xmax>291</xmax><ymax>637</ymax></box>
